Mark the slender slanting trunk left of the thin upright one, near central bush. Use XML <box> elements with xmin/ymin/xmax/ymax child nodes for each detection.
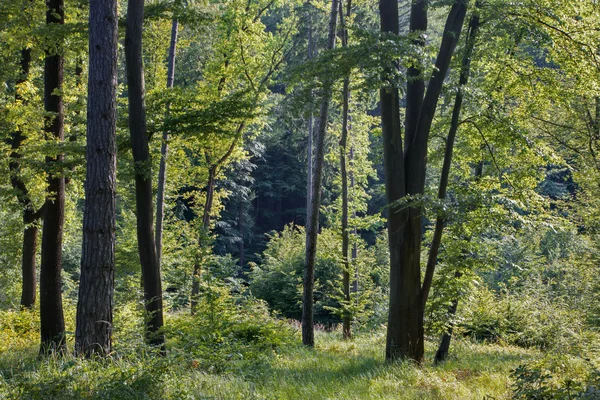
<box><xmin>302</xmin><ymin>0</ymin><xmax>339</xmax><ymax>347</ymax></box>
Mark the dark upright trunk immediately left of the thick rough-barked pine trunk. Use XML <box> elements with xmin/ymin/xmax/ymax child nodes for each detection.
<box><xmin>40</xmin><ymin>0</ymin><xmax>66</xmax><ymax>354</ymax></box>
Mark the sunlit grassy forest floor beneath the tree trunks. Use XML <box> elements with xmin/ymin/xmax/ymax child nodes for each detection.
<box><xmin>0</xmin><ymin>310</ymin><xmax>542</xmax><ymax>400</ymax></box>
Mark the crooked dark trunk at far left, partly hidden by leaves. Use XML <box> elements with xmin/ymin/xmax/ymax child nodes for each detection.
<box><xmin>8</xmin><ymin>48</ymin><xmax>40</xmax><ymax>308</ymax></box>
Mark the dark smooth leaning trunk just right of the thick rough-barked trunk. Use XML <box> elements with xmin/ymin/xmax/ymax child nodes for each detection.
<box><xmin>125</xmin><ymin>0</ymin><xmax>165</xmax><ymax>352</ymax></box>
